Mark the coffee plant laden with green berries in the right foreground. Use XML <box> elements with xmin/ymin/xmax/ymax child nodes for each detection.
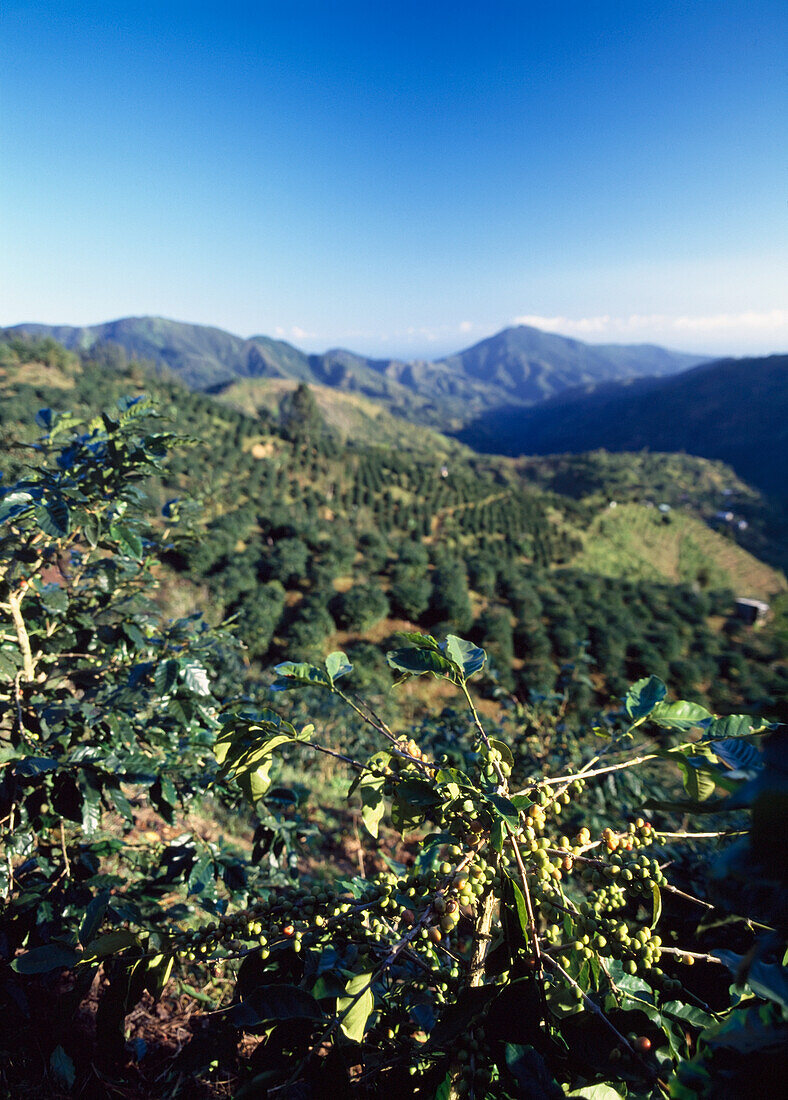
<box><xmin>209</xmin><ymin>635</ymin><xmax>786</xmax><ymax>1098</ymax></box>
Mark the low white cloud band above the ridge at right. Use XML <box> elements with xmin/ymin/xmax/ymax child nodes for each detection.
<box><xmin>513</xmin><ymin>309</ymin><xmax>788</xmax><ymax>354</ymax></box>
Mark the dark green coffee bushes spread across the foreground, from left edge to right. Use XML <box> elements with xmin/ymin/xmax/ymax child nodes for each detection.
<box><xmin>0</xmin><ymin>403</ymin><xmax>788</xmax><ymax>1100</ymax></box>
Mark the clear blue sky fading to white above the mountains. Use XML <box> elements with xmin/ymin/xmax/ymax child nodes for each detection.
<box><xmin>0</xmin><ymin>0</ymin><xmax>788</xmax><ymax>355</ymax></box>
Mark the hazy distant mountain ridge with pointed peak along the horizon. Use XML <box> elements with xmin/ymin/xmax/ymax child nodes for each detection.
<box><xmin>6</xmin><ymin>317</ymin><xmax>703</xmax><ymax>429</ymax></box>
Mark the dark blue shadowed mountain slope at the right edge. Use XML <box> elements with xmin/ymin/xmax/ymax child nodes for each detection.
<box><xmin>458</xmin><ymin>355</ymin><xmax>788</xmax><ymax>496</ymax></box>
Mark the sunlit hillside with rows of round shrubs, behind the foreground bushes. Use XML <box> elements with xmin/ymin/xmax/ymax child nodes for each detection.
<box><xmin>0</xmin><ymin>330</ymin><xmax>788</xmax><ymax>712</ymax></box>
